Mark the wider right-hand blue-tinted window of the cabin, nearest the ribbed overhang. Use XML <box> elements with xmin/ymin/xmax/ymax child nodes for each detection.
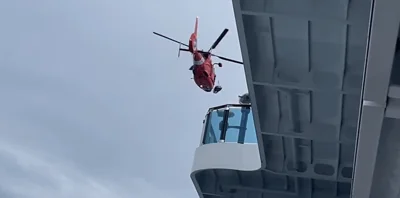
<box><xmin>225</xmin><ymin>107</ymin><xmax>257</xmax><ymax>143</ymax></box>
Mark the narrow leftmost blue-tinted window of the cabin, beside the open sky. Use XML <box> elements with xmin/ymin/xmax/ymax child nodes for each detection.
<box><xmin>203</xmin><ymin>109</ymin><xmax>224</xmax><ymax>144</ymax></box>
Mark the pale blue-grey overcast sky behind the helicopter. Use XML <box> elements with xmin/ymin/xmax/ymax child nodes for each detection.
<box><xmin>0</xmin><ymin>0</ymin><xmax>247</xmax><ymax>198</ymax></box>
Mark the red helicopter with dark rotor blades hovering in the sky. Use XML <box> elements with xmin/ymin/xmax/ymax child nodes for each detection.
<box><xmin>153</xmin><ymin>17</ymin><xmax>243</xmax><ymax>94</ymax></box>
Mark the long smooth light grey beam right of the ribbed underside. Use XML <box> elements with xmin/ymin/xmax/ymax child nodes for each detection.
<box><xmin>352</xmin><ymin>0</ymin><xmax>400</xmax><ymax>198</ymax></box>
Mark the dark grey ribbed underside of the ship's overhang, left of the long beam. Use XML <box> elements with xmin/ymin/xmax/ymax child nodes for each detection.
<box><xmin>195</xmin><ymin>0</ymin><xmax>371</xmax><ymax>198</ymax></box>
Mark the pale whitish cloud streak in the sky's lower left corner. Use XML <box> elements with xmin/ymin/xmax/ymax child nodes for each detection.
<box><xmin>0</xmin><ymin>143</ymin><xmax>180</xmax><ymax>198</ymax></box>
